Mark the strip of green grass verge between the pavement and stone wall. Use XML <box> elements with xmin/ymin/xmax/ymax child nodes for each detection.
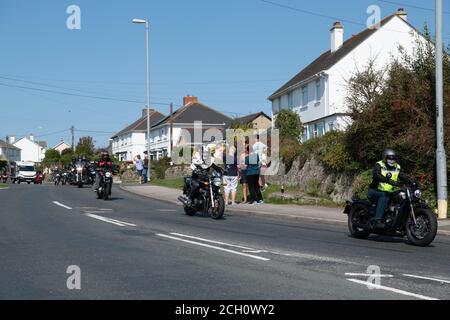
<box><xmin>150</xmin><ymin>178</ymin><xmax>342</xmax><ymax>207</ymax></box>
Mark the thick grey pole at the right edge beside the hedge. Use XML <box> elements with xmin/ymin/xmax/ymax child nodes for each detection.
<box><xmin>436</xmin><ymin>0</ymin><xmax>448</xmax><ymax>219</ymax></box>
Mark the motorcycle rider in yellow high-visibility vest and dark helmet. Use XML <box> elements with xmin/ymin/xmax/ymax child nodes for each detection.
<box><xmin>368</xmin><ymin>149</ymin><xmax>412</xmax><ymax>229</ymax></box>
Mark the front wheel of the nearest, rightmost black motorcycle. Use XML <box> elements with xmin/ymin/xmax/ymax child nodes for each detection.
<box><xmin>406</xmin><ymin>209</ymin><xmax>438</xmax><ymax>247</ymax></box>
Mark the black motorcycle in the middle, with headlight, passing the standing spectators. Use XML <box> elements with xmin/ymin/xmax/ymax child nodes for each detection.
<box><xmin>178</xmin><ymin>164</ymin><xmax>225</xmax><ymax>220</ymax></box>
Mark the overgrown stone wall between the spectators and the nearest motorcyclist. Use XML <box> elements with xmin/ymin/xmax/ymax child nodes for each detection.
<box><xmin>266</xmin><ymin>157</ymin><xmax>354</xmax><ymax>202</ymax></box>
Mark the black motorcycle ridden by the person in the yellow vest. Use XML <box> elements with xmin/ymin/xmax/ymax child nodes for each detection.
<box><xmin>344</xmin><ymin>179</ymin><xmax>438</xmax><ymax>247</ymax></box>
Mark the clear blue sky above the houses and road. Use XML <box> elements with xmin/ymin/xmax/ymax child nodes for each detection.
<box><xmin>0</xmin><ymin>0</ymin><xmax>450</xmax><ymax>146</ymax></box>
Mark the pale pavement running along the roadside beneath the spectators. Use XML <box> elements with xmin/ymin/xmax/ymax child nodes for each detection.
<box><xmin>121</xmin><ymin>184</ymin><xmax>450</xmax><ymax>235</ymax></box>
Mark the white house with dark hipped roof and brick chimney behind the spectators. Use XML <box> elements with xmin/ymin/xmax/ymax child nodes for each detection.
<box><xmin>150</xmin><ymin>96</ymin><xmax>232</xmax><ymax>159</ymax></box>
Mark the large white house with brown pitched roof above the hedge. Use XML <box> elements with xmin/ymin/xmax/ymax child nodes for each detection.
<box><xmin>268</xmin><ymin>8</ymin><xmax>423</xmax><ymax>140</ymax></box>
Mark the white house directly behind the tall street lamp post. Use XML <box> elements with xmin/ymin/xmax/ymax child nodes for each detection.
<box><xmin>111</xmin><ymin>109</ymin><xmax>165</xmax><ymax>161</ymax></box>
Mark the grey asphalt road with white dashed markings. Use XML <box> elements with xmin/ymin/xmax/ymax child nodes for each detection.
<box><xmin>0</xmin><ymin>185</ymin><xmax>450</xmax><ymax>300</ymax></box>
